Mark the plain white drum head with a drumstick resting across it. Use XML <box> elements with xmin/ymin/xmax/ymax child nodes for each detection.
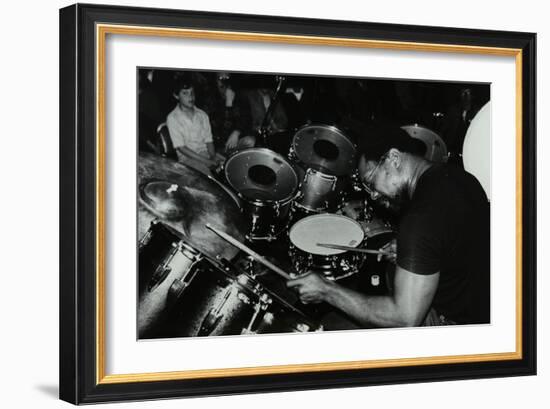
<box><xmin>289</xmin><ymin>214</ymin><xmax>365</xmax><ymax>256</ymax></box>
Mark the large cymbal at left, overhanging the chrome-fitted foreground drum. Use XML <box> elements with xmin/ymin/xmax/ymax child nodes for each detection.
<box><xmin>138</xmin><ymin>153</ymin><xmax>246</xmax><ymax>259</ymax></box>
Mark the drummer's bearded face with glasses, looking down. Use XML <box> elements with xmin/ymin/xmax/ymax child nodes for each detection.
<box><xmin>359</xmin><ymin>149</ymin><xmax>409</xmax><ymax>211</ymax></box>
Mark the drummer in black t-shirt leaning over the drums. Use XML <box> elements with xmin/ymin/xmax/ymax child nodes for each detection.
<box><xmin>287</xmin><ymin>122</ymin><xmax>490</xmax><ymax>327</ymax></box>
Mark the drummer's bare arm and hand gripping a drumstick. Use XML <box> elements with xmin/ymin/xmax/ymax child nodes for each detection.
<box><xmin>288</xmin><ymin>266</ymin><xmax>439</xmax><ymax>327</ymax></box>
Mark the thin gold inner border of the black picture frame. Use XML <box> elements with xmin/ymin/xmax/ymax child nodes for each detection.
<box><xmin>96</xmin><ymin>24</ymin><xmax>523</xmax><ymax>384</ymax></box>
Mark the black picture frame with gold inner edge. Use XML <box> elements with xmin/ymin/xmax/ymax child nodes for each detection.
<box><xmin>59</xmin><ymin>4</ymin><xmax>536</xmax><ymax>404</ymax></box>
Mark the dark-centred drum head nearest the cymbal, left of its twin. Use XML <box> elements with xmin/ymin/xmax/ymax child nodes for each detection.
<box><xmin>225</xmin><ymin>148</ymin><xmax>298</xmax><ymax>202</ymax></box>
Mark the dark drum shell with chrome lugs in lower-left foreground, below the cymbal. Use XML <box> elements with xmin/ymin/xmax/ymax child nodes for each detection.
<box><xmin>138</xmin><ymin>221</ymin><xmax>324</xmax><ymax>339</ymax></box>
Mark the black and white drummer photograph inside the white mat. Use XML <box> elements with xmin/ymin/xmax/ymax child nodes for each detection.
<box><xmin>136</xmin><ymin>67</ymin><xmax>492</xmax><ymax>340</ymax></box>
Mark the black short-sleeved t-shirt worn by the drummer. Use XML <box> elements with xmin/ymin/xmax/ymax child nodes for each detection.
<box><xmin>397</xmin><ymin>165</ymin><xmax>490</xmax><ymax>324</ymax></box>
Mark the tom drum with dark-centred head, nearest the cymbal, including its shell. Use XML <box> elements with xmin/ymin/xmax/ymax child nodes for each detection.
<box><xmin>225</xmin><ymin>148</ymin><xmax>298</xmax><ymax>241</ymax></box>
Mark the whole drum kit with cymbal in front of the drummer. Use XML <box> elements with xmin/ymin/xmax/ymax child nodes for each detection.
<box><xmin>137</xmin><ymin>124</ymin><xmax>452</xmax><ymax>339</ymax></box>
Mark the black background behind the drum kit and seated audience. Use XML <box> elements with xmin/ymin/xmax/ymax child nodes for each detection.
<box><xmin>137</xmin><ymin>67</ymin><xmax>490</xmax><ymax>163</ymax></box>
